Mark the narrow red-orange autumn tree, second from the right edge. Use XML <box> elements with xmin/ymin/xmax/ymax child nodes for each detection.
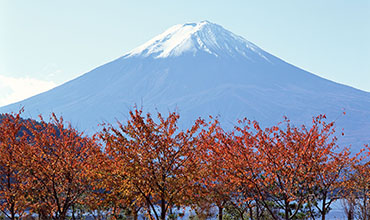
<box><xmin>301</xmin><ymin>115</ymin><xmax>354</xmax><ymax>220</ymax></box>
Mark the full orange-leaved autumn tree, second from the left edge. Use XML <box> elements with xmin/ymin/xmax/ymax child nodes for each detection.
<box><xmin>22</xmin><ymin>114</ymin><xmax>101</xmax><ymax>219</ymax></box>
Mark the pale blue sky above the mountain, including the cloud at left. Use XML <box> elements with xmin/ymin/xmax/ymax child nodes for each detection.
<box><xmin>0</xmin><ymin>0</ymin><xmax>370</xmax><ymax>105</ymax></box>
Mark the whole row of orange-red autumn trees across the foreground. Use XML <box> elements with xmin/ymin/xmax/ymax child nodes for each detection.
<box><xmin>0</xmin><ymin>110</ymin><xmax>370</xmax><ymax>220</ymax></box>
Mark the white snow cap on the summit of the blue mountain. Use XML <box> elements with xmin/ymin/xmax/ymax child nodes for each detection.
<box><xmin>125</xmin><ymin>21</ymin><xmax>267</xmax><ymax>60</ymax></box>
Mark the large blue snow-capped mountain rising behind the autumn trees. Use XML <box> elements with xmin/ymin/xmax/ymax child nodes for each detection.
<box><xmin>0</xmin><ymin>21</ymin><xmax>370</xmax><ymax>150</ymax></box>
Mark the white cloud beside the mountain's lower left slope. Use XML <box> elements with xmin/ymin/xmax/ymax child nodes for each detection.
<box><xmin>0</xmin><ymin>75</ymin><xmax>57</xmax><ymax>106</ymax></box>
